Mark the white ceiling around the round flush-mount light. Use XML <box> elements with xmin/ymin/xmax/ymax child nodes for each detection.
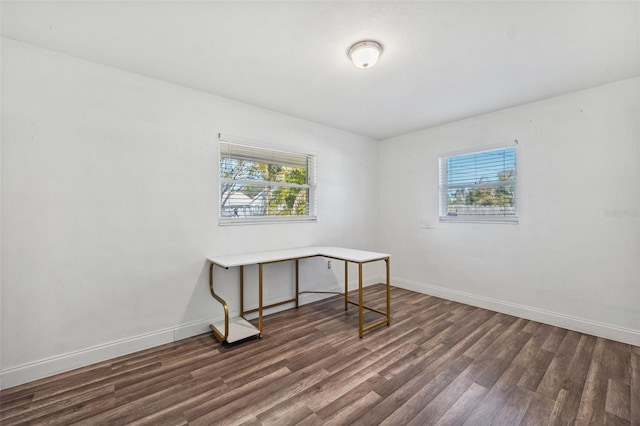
<box><xmin>1</xmin><ymin>1</ymin><xmax>640</xmax><ymax>139</ymax></box>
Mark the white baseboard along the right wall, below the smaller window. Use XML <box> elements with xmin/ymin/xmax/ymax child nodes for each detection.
<box><xmin>391</xmin><ymin>277</ymin><xmax>640</xmax><ymax>346</ymax></box>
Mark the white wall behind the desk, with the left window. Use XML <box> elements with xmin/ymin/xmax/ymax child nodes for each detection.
<box><xmin>1</xmin><ymin>39</ymin><xmax>378</xmax><ymax>387</ymax></box>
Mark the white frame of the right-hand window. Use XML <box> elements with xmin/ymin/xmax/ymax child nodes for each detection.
<box><xmin>438</xmin><ymin>140</ymin><xmax>520</xmax><ymax>224</ymax></box>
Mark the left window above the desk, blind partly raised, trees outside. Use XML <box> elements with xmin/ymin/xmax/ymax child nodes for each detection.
<box><xmin>220</xmin><ymin>136</ymin><xmax>316</xmax><ymax>224</ymax></box>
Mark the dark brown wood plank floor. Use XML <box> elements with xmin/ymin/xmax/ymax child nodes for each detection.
<box><xmin>0</xmin><ymin>285</ymin><xmax>640</xmax><ymax>426</ymax></box>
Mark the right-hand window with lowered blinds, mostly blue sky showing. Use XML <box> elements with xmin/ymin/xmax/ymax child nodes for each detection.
<box><xmin>440</xmin><ymin>146</ymin><xmax>518</xmax><ymax>222</ymax></box>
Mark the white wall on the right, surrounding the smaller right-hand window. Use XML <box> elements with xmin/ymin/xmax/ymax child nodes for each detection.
<box><xmin>379</xmin><ymin>78</ymin><xmax>640</xmax><ymax>345</ymax></box>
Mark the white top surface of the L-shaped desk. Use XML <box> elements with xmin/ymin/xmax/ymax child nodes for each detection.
<box><xmin>208</xmin><ymin>247</ymin><xmax>391</xmax><ymax>268</ymax></box>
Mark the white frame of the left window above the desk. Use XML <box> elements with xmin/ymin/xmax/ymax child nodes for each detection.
<box><xmin>218</xmin><ymin>134</ymin><xmax>317</xmax><ymax>226</ymax></box>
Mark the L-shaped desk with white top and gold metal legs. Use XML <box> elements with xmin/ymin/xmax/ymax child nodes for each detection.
<box><xmin>208</xmin><ymin>247</ymin><xmax>391</xmax><ymax>343</ymax></box>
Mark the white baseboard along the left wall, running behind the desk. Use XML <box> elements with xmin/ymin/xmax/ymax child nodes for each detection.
<box><xmin>0</xmin><ymin>276</ymin><xmax>381</xmax><ymax>389</ymax></box>
